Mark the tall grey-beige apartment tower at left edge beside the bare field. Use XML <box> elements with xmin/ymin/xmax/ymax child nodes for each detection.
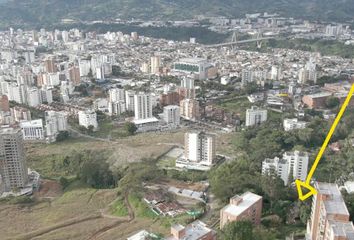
<box><xmin>0</xmin><ymin>128</ymin><xmax>28</xmax><ymax>191</ymax></box>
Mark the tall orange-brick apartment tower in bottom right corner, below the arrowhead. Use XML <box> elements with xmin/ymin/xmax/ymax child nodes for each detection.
<box><xmin>306</xmin><ymin>182</ymin><xmax>354</xmax><ymax>240</ymax></box>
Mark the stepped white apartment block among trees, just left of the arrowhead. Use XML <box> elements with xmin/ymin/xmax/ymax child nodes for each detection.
<box><xmin>262</xmin><ymin>151</ymin><xmax>309</xmax><ymax>185</ymax></box>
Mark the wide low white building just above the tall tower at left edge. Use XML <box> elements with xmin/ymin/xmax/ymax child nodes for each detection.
<box><xmin>20</xmin><ymin>119</ymin><xmax>44</xmax><ymax>141</ymax></box>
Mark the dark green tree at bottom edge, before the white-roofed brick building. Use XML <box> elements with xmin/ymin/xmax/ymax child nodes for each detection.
<box><xmin>221</xmin><ymin>221</ymin><xmax>254</xmax><ymax>240</ymax></box>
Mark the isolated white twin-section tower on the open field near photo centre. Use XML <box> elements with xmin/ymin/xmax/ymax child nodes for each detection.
<box><xmin>184</xmin><ymin>132</ymin><xmax>216</xmax><ymax>166</ymax></box>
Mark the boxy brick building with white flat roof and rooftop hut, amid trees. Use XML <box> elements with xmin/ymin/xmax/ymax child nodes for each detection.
<box><xmin>220</xmin><ymin>192</ymin><xmax>263</xmax><ymax>228</ymax></box>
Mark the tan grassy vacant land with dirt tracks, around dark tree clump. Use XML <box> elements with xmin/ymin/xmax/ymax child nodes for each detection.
<box><xmin>0</xmin><ymin>131</ymin><xmax>189</xmax><ymax>240</ymax></box>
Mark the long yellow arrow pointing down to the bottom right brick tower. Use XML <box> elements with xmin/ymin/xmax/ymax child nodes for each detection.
<box><xmin>295</xmin><ymin>84</ymin><xmax>354</xmax><ymax>201</ymax></box>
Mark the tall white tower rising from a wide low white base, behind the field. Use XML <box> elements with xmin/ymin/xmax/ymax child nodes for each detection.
<box><xmin>134</xmin><ymin>93</ymin><xmax>153</xmax><ymax>120</ymax></box>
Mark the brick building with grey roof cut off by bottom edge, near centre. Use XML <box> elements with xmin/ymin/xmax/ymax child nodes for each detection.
<box><xmin>166</xmin><ymin>220</ymin><xmax>216</xmax><ymax>240</ymax></box>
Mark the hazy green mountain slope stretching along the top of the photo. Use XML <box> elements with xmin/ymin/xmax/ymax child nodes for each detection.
<box><xmin>0</xmin><ymin>0</ymin><xmax>354</xmax><ymax>26</ymax></box>
